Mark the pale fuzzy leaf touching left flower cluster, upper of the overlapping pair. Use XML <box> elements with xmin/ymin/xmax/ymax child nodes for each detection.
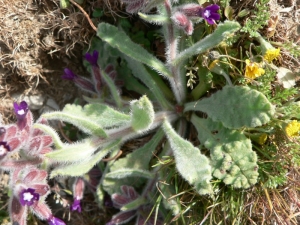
<box><xmin>45</xmin><ymin>138</ymin><xmax>100</xmax><ymax>163</ymax></box>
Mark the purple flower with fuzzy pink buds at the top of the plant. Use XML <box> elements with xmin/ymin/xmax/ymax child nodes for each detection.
<box><xmin>172</xmin><ymin>3</ymin><xmax>221</xmax><ymax>35</ymax></box>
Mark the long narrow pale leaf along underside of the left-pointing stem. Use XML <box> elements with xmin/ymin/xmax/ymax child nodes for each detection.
<box><xmin>50</xmin><ymin>140</ymin><xmax>121</xmax><ymax>178</ymax></box>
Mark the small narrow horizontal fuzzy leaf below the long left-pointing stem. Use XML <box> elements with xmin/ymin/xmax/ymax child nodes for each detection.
<box><xmin>106</xmin><ymin>168</ymin><xmax>154</xmax><ymax>179</ymax></box>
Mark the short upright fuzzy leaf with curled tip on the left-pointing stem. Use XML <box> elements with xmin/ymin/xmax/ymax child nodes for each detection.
<box><xmin>130</xmin><ymin>95</ymin><xmax>155</xmax><ymax>132</ymax></box>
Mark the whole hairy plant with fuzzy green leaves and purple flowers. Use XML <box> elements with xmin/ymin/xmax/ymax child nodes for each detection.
<box><xmin>0</xmin><ymin>0</ymin><xmax>298</xmax><ymax>225</ymax></box>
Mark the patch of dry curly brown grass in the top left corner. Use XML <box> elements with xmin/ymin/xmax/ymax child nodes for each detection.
<box><xmin>0</xmin><ymin>0</ymin><xmax>94</xmax><ymax>122</ymax></box>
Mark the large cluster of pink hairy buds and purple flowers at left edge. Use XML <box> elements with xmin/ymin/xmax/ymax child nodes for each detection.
<box><xmin>0</xmin><ymin>101</ymin><xmax>65</xmax><ymax>225</ymax></box>
